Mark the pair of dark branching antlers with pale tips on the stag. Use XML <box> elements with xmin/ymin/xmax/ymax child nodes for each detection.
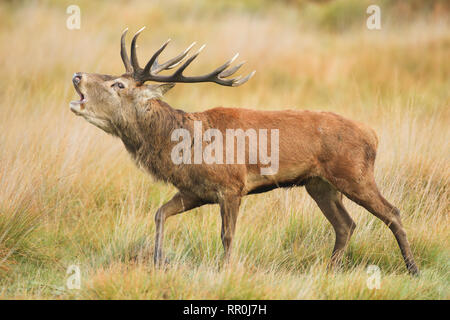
<box><xmin>120</xmin><ymin>27</ymin><xmax>255</xmax><ymax>87</ymax></box>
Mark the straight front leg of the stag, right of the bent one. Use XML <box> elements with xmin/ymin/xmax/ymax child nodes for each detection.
<box><xmin>220</xmin><ymin>196</ymin><xmax>241</xmax><ymax>262</ymax></box>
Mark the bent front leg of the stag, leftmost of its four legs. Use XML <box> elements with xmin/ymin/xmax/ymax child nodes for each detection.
<box><xmin>153</xmin><ymin>192</ymin><xmax>204</xmax><ymax>266</ymax></box>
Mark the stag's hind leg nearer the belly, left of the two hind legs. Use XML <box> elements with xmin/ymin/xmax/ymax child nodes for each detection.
<box><xmin>305</xmin><ymin>178</ymin><xmax>356</xmax><ymax>267</ymax></box>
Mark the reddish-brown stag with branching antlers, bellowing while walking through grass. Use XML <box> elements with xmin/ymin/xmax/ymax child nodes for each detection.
<box><xmin>70</xmin><ymin>27</ymin><xmax>419</xmax><ymax>275</ymax></box>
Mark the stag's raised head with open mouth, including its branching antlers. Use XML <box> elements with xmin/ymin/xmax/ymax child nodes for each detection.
<box><xmin>70</xmin><ymin>28</ymin><xmax>255</xmax><ymax>133</ymax></box>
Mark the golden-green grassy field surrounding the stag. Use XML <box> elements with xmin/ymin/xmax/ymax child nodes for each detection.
<box><xmin>0</xmin><ymin>0</ymin><xmax>450</xmax><ymax>299</ymax></box>
